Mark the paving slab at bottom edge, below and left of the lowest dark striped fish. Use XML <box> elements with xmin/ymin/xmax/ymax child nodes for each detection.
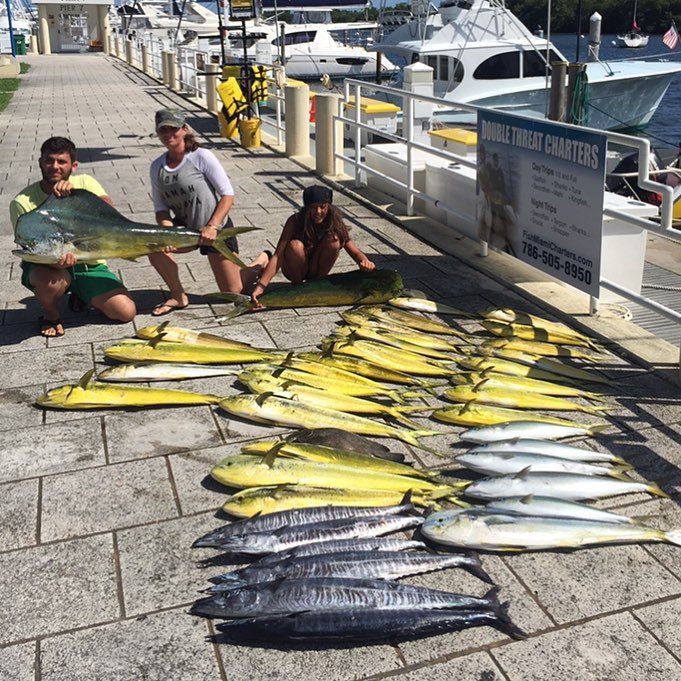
<box><xmin>40</xmin><ymin>610</ymin><xmax>221</xmax><ymax>681</ymax></box>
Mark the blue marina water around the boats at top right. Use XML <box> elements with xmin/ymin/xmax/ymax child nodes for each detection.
<box><xmin>551</xmin><ymin>35</ymin><xmax>681</xmax><ymax>149</ymax></box>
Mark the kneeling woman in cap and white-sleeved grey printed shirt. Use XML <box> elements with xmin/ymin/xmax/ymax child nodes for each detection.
<box><xmin>149</xmin><ymin>109</ymin><xmax>268</xmax><ymax>317</ymax></box>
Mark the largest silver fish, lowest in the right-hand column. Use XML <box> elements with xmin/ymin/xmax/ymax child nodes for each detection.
<box><xmin>421</xmin><ymin>509</ymin><xmax>681</xmax><ymax>551</ymax></box>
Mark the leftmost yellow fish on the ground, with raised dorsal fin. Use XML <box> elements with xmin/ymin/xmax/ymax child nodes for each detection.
<box><xmin>36</xmin><ymin>371</ymin><xmax>223</xmax><ymax>409</ymax></box>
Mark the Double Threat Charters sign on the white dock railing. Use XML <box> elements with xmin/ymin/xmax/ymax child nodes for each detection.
<box><xmin>477</xmin><ymin>111</ymin><xmax>606</xmax><ymax>297</ymax></box>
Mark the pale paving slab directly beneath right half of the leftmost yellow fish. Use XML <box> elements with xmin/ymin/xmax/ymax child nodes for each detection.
<box><xmin>104</xmin><ymin>404</ymin><xmax>222</xmax><ymax>463</ymax></box>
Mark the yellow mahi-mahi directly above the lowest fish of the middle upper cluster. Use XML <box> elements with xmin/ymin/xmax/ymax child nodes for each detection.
<box><xmin>234</xmin><ymin>371</ymin><xmax>424</xmax><ymax>428</ymax></box>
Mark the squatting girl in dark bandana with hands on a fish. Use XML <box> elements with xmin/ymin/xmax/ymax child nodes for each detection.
<box><xmin>251</xmin><ymin>185</ymin><xmax>376</xmax><ymax>305</ymax></box>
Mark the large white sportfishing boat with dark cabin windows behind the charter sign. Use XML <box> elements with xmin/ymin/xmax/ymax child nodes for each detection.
<box><xmin>374</xmin><ymin>0</ymin><xmax>681</xmax><ymax>130</ymax></box>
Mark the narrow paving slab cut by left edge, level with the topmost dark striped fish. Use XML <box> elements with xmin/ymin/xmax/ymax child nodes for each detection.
<box><xmin>0</xmin><ymin>480</ymin><xmax>39</xmax><ymax>551</ymax></box>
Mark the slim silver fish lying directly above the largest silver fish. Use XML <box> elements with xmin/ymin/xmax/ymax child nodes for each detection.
<box><xmin>485</xmin><ymin>495</ymin><xmax>647</xmax><ymax>525</ymax></box>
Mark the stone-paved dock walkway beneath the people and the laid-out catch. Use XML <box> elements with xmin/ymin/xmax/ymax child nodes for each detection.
<box><xmin>0</xmin><ymin>54</ymin><xmax>681</xmax><ymax>681</ymax></box>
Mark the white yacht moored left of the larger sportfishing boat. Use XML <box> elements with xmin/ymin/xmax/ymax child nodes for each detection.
<box><xmin>220</xmin><ymin>17</ymin><xmax>397</xmax><ymax>80</ymax></box>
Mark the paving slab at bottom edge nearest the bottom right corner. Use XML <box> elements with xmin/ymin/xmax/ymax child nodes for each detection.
<box><xmin>492</xmin><ymin>613</ymin><xmax>681</xmax><ymax>681</ymax></box>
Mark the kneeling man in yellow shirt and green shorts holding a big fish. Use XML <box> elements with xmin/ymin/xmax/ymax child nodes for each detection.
<box><xmin>9</xmin><ymin>137</ymin><xmax>137</xmax><ymax>338</ymax></box>
